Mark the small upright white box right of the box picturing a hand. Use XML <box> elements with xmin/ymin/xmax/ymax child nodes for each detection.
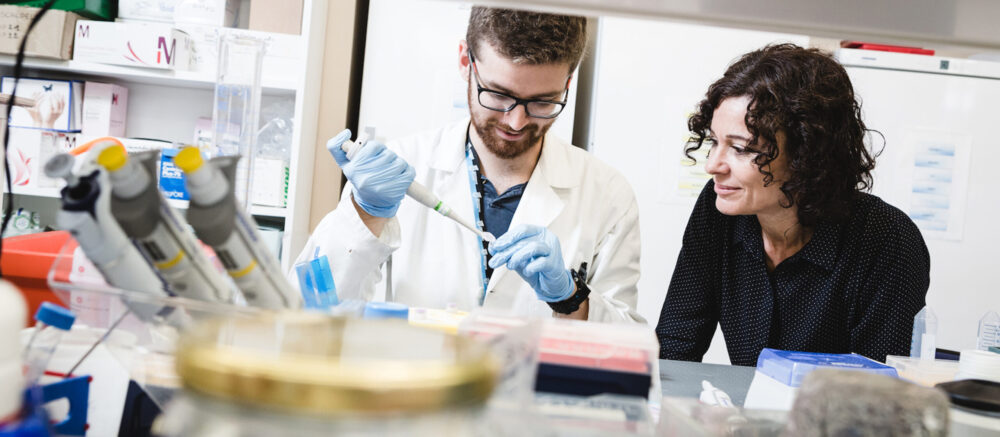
<box><xmin>82</xmin><ymin>82</ymin><xmax>128</xmax><ymax>137</ymax></box>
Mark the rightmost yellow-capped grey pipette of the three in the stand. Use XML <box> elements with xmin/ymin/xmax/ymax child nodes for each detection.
<box><xmin>174</xmin><ymin>147</ymin><xmax>302</xmax><ymax>309</ymax></box>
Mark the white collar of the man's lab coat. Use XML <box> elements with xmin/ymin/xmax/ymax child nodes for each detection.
<box><xmin>431</xmin><ymin>117</ymin><xmax>580</xmax><ymax>188</ymax></box>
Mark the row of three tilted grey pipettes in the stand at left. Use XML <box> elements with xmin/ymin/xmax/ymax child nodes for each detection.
<box><xmin>45</xmin><ymin>138</ymin><xmax>301</xmax><ymax>320</ymax></box>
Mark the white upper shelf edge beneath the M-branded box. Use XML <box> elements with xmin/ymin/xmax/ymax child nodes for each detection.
<box><xmin>0</xmin><ymin>55</ymin><xmax>295</xmax><ymax>95</ymax></box>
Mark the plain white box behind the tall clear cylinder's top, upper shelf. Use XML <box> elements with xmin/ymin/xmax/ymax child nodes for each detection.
<box><xmin>177</xmin><ymin>24</ymin><xmax>305</xmax><ymax>88</ymax></box>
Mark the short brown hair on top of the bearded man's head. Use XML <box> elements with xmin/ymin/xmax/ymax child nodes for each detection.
<box><xmin>465</xmin><ymin>6</ymin><xmax>587</xmax><ymax>71</ymax></box>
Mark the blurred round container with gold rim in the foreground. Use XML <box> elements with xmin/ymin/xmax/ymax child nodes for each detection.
<box><xmin>160</xmin><ymin>312</ymin><xmax>499</xmax><ymax>437</ymax></box>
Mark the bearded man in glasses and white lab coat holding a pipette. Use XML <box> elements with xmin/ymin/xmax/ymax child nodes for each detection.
<box><xmin>296</xmin><ymin>7</ymin><xmax>643</xmax><ymax>322</ymax></box>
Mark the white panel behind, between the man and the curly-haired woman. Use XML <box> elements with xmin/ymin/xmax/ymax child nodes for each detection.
<box><xmin>590</xmin><ymin>18</ymin><xmax>808</xmax><ymax>363</ymax></box>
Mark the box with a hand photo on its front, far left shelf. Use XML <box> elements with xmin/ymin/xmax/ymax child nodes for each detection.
<box><xmin>0</xmin><ymin>76</ymin><xmax>83</xmax><ymax>132</ymax></box>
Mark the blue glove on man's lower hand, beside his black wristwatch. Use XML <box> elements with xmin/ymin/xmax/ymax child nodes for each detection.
<box><xmin>490</xmin><ymin>224</ymin><xmax>573</xmax><ymax>302</ymax></box>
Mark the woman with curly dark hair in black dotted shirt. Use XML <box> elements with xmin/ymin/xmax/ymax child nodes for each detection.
<box><xmin>656</xmin><ymin>44</ymin><xmax>930</xmax><ymax>366</ymax></box>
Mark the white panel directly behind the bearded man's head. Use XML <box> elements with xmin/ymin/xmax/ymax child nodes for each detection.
<box><xmin>360</xmin><ymin>0</ymin><xmax>578</xmax><ymax>142</ymax></box>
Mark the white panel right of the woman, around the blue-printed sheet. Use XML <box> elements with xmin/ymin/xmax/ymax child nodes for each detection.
<box><xmin>847</xmin><ymin>63</ymin><xmax>1000</xmax><ymax>350</ymax></box>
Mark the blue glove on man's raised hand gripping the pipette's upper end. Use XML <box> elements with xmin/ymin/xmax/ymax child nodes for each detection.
<box><xmin>326</xmin><ymin>130</ymin><xmax>416</xmax><ymax>218</ymax></box>
